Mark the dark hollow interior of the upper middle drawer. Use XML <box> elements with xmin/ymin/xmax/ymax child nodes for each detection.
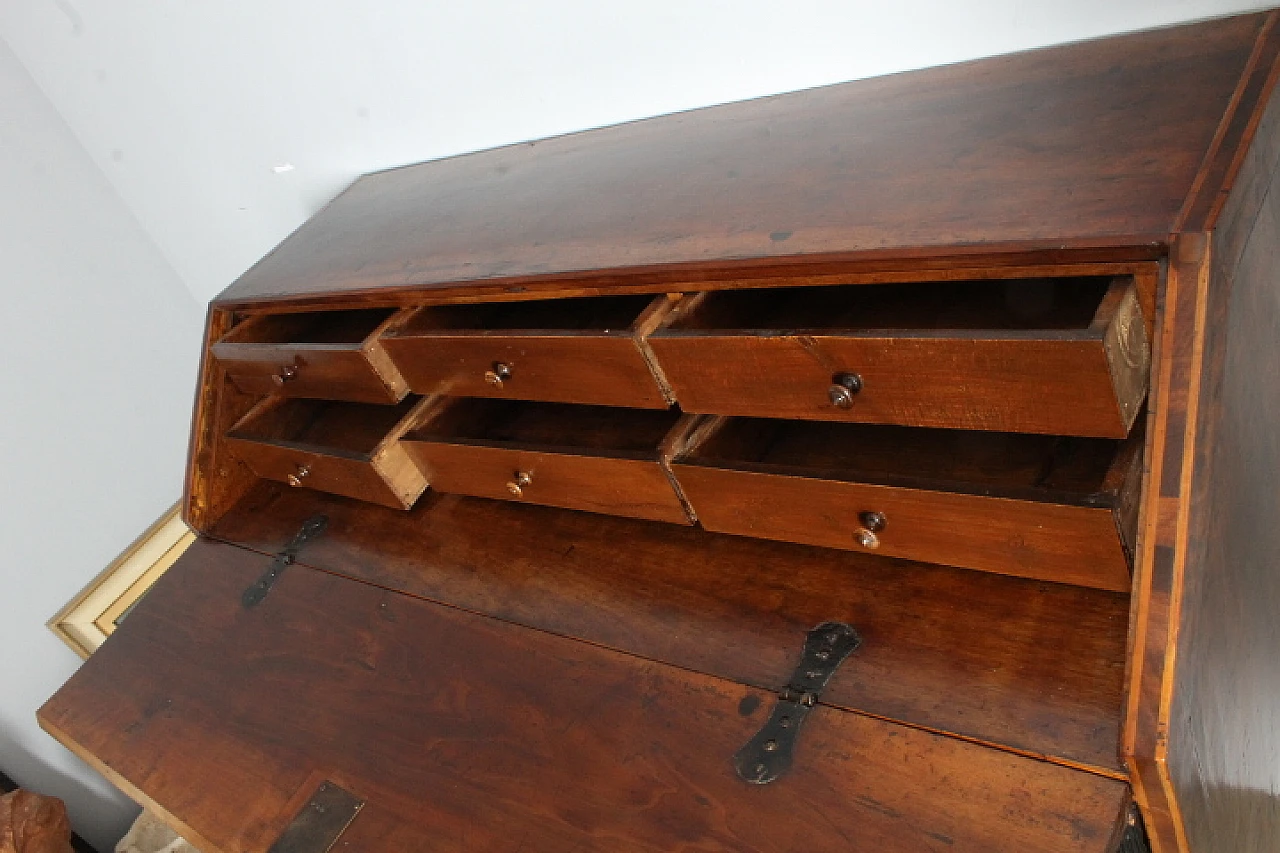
<box><xmin>388</xmin><ymin>295</ymin><xmax>654</xmax><ymax>337</ymax></box>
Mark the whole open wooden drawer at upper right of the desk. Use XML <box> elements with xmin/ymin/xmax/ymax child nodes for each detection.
<box><xmin>648</xmin><ymin>277</ymin><xmax>1151</xmax><ymax>438</ymax></box>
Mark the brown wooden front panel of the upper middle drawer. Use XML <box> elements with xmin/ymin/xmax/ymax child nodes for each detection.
<box><xmin>385</xmin><ymin>334</ymin><xmax>668</xmax><ymax>409</ymax></box>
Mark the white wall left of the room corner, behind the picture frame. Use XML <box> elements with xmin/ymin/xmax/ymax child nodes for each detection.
<box><xmin>0</xmin><ymin>44</ymin><xmax>204</xmax><ymax>852</ymax></box>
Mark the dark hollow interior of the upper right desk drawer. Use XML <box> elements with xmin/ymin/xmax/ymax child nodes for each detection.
<box><xmin>655</xmin><ymin>275</ymin><xmax>1128</xmax><ymax>336</ymax></box>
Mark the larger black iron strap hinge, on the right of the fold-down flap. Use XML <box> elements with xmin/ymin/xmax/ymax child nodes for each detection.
<box><xmin>733</xmin><ymin>622</ymin><xmax>863</xmax><ymax>785</ymax></box>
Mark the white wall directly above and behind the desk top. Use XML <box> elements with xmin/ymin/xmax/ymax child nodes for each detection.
<box><xmin>0</xmin><ymin>0</ymin><xmax>1260</xmax><ymax>301</ymax></box>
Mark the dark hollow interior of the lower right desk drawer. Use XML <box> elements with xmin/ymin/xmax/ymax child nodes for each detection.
<box><xmin>676</xmin><ymin>418</ymin><xmax>1140</xmax><ymax>503</ymax></box>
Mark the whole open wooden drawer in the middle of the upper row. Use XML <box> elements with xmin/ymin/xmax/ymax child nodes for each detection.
<box><xmin>383</xmin><ymin>296</ymin><xmax>675</xmax><ymax>409</ymax></box>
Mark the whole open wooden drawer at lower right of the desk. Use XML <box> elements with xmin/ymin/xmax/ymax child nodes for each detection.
<box><xmin>671</xmin><ymin>418</ymin><xmax>1142</xmax><ymax>592</ymax></box>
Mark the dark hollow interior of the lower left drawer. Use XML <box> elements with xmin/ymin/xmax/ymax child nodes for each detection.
<box><xmin>228</xmin><ymin>396</ymin><xmax>421</xmax><ymax>460</ymax></box>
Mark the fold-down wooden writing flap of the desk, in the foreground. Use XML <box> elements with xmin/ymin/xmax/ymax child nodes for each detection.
<box><xmin>40</xmin><ymin>542</ymin><xmax>1126</xmax><ymax>853</ymax></box>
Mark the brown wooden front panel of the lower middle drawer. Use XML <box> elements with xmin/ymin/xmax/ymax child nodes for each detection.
<box><xmin>404</xmin><ymin>441</ymin><xmax>691</xmax><ymax>524</ymax></box>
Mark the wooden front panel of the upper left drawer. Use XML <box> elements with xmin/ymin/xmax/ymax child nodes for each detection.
<box><xmin>214</xmin><ymin>343</ymin><xmax>408</xmax><ymax>403</ymax></box>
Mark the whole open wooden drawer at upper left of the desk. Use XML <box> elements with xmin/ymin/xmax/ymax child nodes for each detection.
<box><xmin>212</xmin><ymin>309</ymin><xmax>408</xmax><ymax>403</ymax></box>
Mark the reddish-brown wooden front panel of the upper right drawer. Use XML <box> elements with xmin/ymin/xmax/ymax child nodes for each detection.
<box><xmin>649</xmin><ymin>333</ymin><xmax>1147</xmax><ymax>438</ymax></box>
